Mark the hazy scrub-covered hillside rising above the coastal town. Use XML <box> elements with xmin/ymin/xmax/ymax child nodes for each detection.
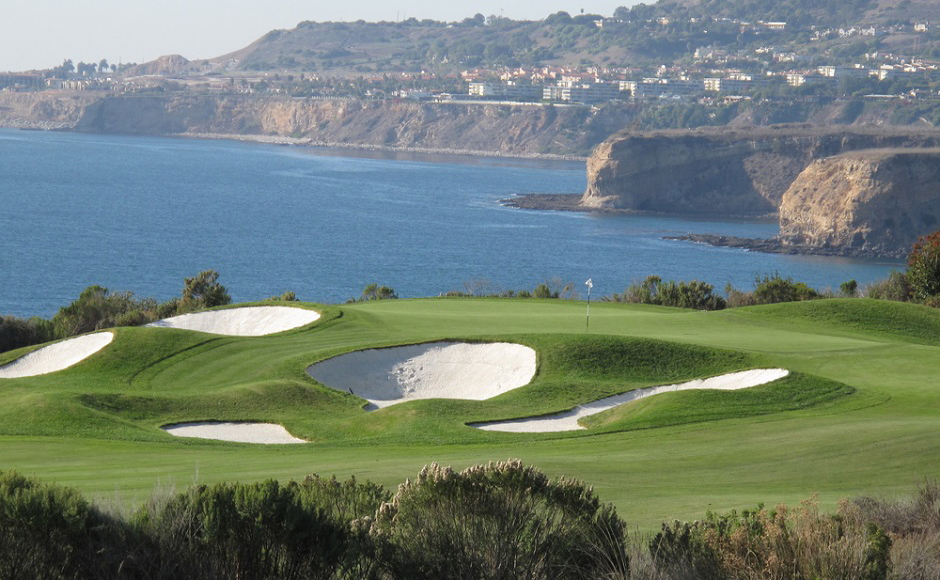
<box><xmin>169</xmin><ymin>0</ymin><xmax>940</xmax><ymax>75</ymax></box>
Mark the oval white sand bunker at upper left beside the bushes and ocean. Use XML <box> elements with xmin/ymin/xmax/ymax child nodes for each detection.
<box><xmin>147</xmin><ymin>306</ymin><xmax>320</xmax><ymax>336</ymax></box>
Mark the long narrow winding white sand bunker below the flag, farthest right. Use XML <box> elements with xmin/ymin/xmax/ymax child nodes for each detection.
<box><xmin>470</xmin><ymin>369</ymin><xmax>790</xmax><ymax>433</ymax></box>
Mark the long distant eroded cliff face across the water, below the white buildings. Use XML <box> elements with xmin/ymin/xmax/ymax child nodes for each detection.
<box><xmin>70</xmin><ymin>95</ymin><xmax>631</xmax><ymax>157</ymax></box>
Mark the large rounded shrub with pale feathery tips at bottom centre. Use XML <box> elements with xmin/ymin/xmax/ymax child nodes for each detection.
<box><xmin>372</xmin><ymin>460</ymin><xmax>627</xmax><ymax>580</ymax></box>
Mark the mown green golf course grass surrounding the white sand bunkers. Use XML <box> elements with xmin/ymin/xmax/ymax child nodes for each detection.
<box><xmin>0</xmin><ymin>299</ymin><xmax>940</xmax><ymax>529</ymax></box>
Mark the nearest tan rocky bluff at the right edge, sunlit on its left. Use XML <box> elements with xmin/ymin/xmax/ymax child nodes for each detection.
<box><xmin>780</xmin><ymin>149</ymin><xmax>940</xmax><ymax>255</ymax></box>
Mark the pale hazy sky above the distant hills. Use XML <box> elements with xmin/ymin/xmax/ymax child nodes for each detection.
<box><xmin>0</xmin><ymin>0</ymin><xmax>653</xmax><ymax>71</ymax></box>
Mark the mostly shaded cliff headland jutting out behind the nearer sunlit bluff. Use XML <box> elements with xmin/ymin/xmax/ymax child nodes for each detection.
<box><xmin>581</xmin><ymin>126</ymin><xmax>940</xmax><ymax>215</ymax></box>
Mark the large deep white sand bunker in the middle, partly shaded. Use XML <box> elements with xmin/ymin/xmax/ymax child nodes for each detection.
<box><xmin>307</xmin><ymin>342</ymin><xmax>535</xmax><ymax>410</ymax></box>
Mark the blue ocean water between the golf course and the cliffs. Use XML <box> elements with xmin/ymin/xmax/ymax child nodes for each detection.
<box><xmin>0</xmin><ymin>130</ymin><xmax>901</xmax><ymax>316</ymax></box>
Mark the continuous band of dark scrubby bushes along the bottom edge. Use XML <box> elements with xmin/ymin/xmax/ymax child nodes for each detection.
<box><xmin>0</xmin><ymin>468</ymin><xmax>940</xmax><ymax>580</ymax></box>
